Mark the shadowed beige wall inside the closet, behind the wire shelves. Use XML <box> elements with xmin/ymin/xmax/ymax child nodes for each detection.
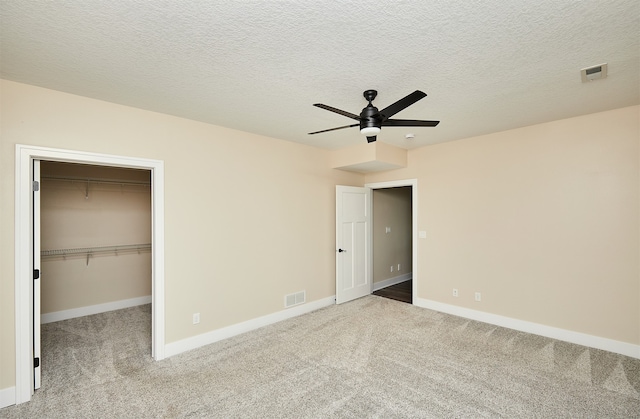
<box><xmin>40</xmin><ymin>161</ymin><xmax>151</xmax><ymax>314</ymax></box>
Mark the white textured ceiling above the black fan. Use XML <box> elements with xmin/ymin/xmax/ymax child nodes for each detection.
<box><xmin>0</xmin><ymin>0</ymin><xmax>640</xmax><ymax>149</ymax></box>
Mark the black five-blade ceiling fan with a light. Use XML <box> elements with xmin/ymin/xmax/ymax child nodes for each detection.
<box><xmin>309</xmin><ymin>90</ymin><xmax>440</xmax><ymax>143</ymax></box>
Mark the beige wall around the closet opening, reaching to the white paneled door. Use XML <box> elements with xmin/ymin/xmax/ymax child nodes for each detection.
<box><xmin>0</xmin><ymin>81</ymin><xmax>364</xmax><ymax>389</ymax></box>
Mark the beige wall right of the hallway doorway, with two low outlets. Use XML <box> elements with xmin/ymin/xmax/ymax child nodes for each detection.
<box><xmin>366</xmin><ymin>106</ymin><xmax>640</xmax><ymax>344</ymax></box>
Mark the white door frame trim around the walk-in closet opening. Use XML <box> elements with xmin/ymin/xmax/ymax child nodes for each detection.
<box><xmin>14</xmin><ymin>144</ymin><xmax>165</xmax><ymax>404</ymax></box>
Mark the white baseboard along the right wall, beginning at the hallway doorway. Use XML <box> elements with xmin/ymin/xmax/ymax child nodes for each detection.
<box><xmin>413</xmin><ymin>298</ymin><xmax>640</xmax><ymax>359</ymax></box>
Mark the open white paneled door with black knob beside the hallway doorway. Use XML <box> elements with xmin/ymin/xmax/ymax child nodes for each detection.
<box><xmin>336</xmin><ymin>185</ymin><xmax>373</xmax><ymax>304</ymax></box>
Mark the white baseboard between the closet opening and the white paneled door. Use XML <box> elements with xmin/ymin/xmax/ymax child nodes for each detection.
<box><xmin>164</xmin><ymin>296</ymin><xmax>336</xmax><ymax>357</ymax></box>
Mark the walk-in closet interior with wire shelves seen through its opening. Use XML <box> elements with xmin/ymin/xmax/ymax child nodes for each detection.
<box><xmin>34</xmin><ymin>160</ymin><xmax>152</xmax><ymax>391</ymax></box>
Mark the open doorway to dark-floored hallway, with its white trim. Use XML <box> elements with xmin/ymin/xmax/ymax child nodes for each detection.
<box><xmin>365</xmin><ymin>179</ymin><xmax>418</xmax><ymax>304</ymax></box>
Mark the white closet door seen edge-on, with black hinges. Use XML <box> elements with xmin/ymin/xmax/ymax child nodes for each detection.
<box><xmin>31</xmin><ymin>160</ymin><xmax>41</xmax><ymax>390</ymax></box>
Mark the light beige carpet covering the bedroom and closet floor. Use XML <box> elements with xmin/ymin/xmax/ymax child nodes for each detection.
<box><xmin>0</xmin><ymin>296</ymin><xmax>640</xmax><ymax>418</ymax></box>
